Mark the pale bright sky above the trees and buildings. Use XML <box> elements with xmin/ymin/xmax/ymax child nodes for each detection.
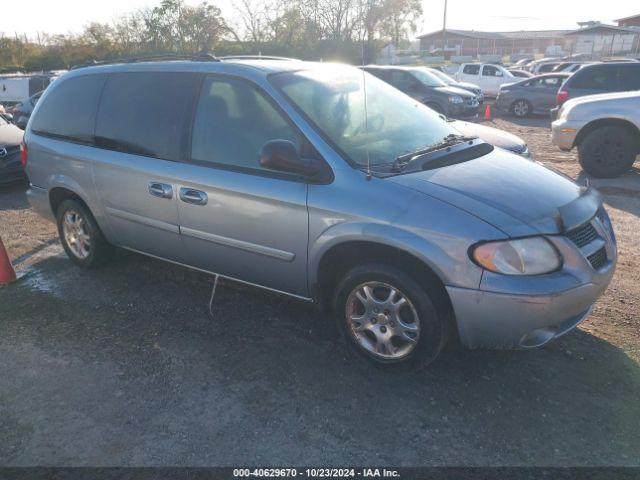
<box><xmin>0</xmin><ymin>0</ymin><xmax>640</xmax><ymax>37</ymax></box>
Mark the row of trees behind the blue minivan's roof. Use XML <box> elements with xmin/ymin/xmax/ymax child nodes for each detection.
<box><xmin>0</xmin><ymin>0</ymin><xmax>422</xmax><ymax>73</ymax></box>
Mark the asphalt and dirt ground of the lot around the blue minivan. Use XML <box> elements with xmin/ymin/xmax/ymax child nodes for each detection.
<box><xmin>0</xmin><ymin>114</ymin><xmax>640</xmax><ymax>466</ymax></box>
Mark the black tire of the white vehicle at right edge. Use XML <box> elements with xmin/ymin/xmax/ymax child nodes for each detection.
<box><xmin>578</xmin><ymin>127</ymin><xmax>640</xmax><ymax>178</ymax></box>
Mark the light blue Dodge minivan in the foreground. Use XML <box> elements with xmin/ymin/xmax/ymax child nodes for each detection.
<box><xmin>23</xmin><ymin>58</ymin><xmax>616</xmax><ymax>367</ymax></box>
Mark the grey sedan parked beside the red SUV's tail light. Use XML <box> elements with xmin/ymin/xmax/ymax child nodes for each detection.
<box><xmin>496</xmin><ymin>73</ymin><xmax>569</xmax><ymax>117</ymax></box>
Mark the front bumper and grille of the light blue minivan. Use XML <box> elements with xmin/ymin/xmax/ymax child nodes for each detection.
<box><xmin>446</xmin><ymin>209</ymin><xmax>617</xmax><ymax>348</ymax></box>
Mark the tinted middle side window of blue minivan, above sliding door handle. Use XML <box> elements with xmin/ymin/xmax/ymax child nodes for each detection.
<box><xmin>96</xmin><ymin>72</ymin><xmax>199</xmax><ymax>160</ymax></box>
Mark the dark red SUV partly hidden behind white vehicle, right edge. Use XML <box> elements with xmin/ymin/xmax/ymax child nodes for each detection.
<box><xmin>551</xmin><ymin>62</ymin><xmax>640</xmax><ymax>118</ymax></box>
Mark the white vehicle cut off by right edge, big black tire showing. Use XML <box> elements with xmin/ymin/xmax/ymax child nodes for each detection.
<box><xmin>551</xmin><ymin>92</ymin><xmax>640</xmax><ymax>177</ymax></box>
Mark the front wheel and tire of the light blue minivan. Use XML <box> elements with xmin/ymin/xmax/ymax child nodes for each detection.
<box><xmin>334</xmin><ymin>263</ymin><xmax>448</xmax><ymax>369</ymax></box>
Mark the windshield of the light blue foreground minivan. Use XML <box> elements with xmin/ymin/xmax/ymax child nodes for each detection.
<box><xmin>271</xmin><ymin>65</ymin><xmax>458</xmax><ymax>168</ymax></box>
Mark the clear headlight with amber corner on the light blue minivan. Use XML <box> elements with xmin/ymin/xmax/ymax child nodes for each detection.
<box><xmin>472</xmin><ymin>237</ymin><xmax>562</xmax><ymax>275</ymax></box>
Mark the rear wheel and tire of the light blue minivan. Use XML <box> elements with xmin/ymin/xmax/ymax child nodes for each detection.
<box><xmin>56</xmin><ymin>199</ymin><xmax>112</xmax><ymax>268</ymax></box>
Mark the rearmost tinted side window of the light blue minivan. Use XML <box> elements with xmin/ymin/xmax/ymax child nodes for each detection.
<box><xmin>31</xmin><ymin>75</ymin><xmax>105</xmax><ymax>143</ymax></box>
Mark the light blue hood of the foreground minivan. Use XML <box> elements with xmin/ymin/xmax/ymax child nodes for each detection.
<box><xmin>389</xmin><ymin>149</ymin><xmax>601</xmax><ymax>237</ymax></box>
